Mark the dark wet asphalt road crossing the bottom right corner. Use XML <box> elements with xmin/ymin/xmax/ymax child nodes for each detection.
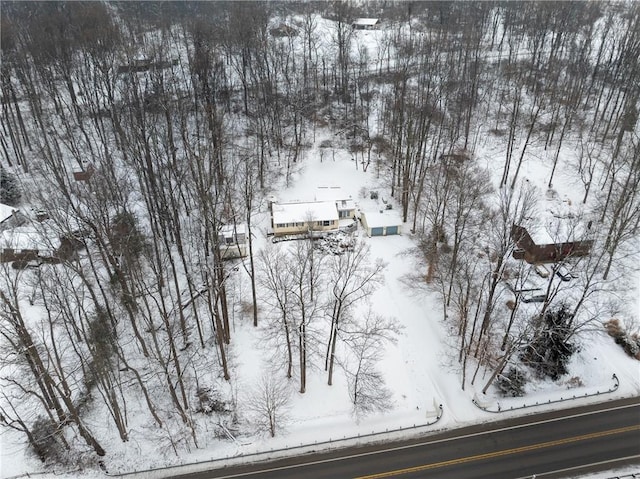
<box><xmin>174</xmin><ymin>398</ymin><xmax>640</xmax><ymax>479</ymax></box>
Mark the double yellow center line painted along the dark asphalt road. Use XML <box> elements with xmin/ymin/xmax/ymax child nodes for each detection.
<box><xmin>355</xmin><ymin>425</ymin><xmax>640</xmax><ymax>479</ymax></box>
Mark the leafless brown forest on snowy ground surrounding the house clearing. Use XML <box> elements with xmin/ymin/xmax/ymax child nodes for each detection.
<box><xmin>0</xmin><ymin>1</ymin><xmax>640</xmax><ymax>470</ymax></box>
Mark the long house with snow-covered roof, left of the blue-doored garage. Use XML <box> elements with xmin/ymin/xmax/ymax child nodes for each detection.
<box><xmin>271</xmin><ymin>201</ymin><xmax>339</xmax><ymax>236</ymax></box>
